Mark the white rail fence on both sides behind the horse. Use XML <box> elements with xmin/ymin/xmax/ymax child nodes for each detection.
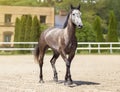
<box><xmin>0</xmin><ymin>42</ymin><xmax>120</xmax><ymax>54</ymax></box>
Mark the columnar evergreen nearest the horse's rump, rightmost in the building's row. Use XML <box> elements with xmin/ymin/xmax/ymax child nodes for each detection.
<box><xmin>30</xmin><ymin>16</ymin><xmax>40</xmax><ymax>42</ymax></box>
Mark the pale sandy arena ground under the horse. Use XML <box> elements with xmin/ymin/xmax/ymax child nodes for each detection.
<box><xmin>0</xmin><ymin>55</ymin><xmax>120</xmax><ymax>92</ymax></box>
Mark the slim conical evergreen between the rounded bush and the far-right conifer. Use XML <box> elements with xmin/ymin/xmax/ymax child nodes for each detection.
<box><xmin>93</xmin><ymin>16</ymin><xmax>104</xmax><ymax>42</ymax></box>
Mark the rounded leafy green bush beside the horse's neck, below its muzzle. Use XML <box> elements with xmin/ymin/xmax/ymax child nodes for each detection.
<box><xmin>76</xmin><ymin>22</ymin><xmax>96</xmax><ymax>42</ymax></box>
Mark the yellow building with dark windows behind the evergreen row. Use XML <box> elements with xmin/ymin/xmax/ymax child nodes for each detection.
<box><xmin>0</xmin><ymin>6</ymin><xmax>54</xmax><ymax>42</ymax></box>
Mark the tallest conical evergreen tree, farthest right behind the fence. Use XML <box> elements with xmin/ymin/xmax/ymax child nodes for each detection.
<box><xmin>107</xmin><ymin>11</ymin><xmax>118</xmax><ymax>42</ymax></box>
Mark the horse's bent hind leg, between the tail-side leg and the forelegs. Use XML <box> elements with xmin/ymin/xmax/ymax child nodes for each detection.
<box><xmin>50</xmin><ymin>52</ymin><xmax>59</xmax><ymax>82</ymax></box>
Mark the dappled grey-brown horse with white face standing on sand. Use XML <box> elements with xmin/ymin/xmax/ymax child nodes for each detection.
<box><xmin>35</xmin><ymin>4</ymin><xmax>83</xmax><ymax>85</ymax></box>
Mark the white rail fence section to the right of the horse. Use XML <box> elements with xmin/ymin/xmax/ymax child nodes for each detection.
<box><xmin>77</xmin><ymin>42</ymin><xmax>120</xmax><ymax>54</ymax></box>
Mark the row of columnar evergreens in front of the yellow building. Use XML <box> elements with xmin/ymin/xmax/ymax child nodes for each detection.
<box><xmin>14</xmin><ymin>15</ymin><xmax>47</xmax><ymax>54</ymax></box>
